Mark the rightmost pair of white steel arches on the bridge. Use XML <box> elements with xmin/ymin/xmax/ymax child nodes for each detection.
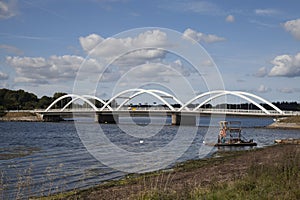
<box><xmin>179</xmin><ymin>90</ymin><xmax>283</xmax><ymax>114</ymax></box>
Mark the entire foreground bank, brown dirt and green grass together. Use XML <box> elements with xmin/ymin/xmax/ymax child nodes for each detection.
<box><xmin>40</xmin><ymin>145</ymin><xmax>300</xmax><ymax>200</ymax></box>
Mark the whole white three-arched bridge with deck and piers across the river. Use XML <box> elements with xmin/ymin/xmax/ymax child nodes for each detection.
<box><xmin>36</xmin><ymin>89</ymin><xmax>300</xmax><ymax>124</ymax></box>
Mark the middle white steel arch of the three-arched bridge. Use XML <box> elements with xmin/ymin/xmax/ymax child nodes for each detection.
<box><xmin>100</xmin><ymin>88</ymin><xmax>175</xmax><ymax>111</ymax></box>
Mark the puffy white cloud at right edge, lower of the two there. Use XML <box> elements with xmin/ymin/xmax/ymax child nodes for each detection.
<box><xmin>269</xmin><ymin>53</ymin><xmax>300</xmax><ymax>77</ymax></box>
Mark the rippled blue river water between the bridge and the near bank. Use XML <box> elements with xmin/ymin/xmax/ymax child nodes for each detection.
<box><xmin>0</xmin><ymin>117</ymin><xmax>300</xmax><ymax>199</ymax></box>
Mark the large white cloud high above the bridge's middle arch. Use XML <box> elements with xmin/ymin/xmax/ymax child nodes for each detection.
<box><xmin>79</xmin><ymin>30</ymin><xmax>169</xmax><ymax>66</ymax></box>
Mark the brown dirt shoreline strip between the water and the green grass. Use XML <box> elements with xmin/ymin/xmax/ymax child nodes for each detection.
<box><xmin>46</xmin><ymin>145</ymin><xmax>300</xmax><ymax>200</ymax></box>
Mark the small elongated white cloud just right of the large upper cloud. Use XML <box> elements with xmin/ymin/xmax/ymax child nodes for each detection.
<box><xmin>183</xmin><ymin>28</ymin><xmax>225</xmax><ymax>43</ymax></box>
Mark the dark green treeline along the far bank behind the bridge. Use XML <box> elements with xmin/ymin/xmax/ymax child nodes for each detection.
<box><xmin>0</xmin><ymin>89</ymin><xmax>300</xmax><ymax>111</ymax></box>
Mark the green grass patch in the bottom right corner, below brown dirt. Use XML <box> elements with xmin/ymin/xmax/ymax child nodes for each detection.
<box><xmin>137</xmin><ymin>145</ymin><xmax>300</xmax><ymax>200</ymax></box>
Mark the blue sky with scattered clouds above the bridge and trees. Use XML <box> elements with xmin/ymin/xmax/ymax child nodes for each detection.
<box><xmin>0</xmin><ymin>0</ymin><xmax>300</xmax><ymax>102</ymax></box>
